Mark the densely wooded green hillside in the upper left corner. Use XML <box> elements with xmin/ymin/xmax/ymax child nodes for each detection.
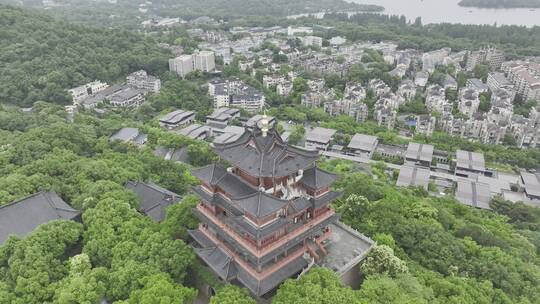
<box><xmin>0</xmin><ymin>6</ymin><xmax>169</xmax><ymax>106</ymax></box>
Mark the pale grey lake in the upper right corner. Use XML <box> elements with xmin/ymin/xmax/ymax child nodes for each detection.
<box><xmin>348</xmin><ymin>0</ymin><xmax>540</xmax><ymax>27</ymax></box>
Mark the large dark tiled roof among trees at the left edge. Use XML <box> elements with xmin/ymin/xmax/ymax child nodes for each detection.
<box><xmin>0</xmin><ymin>192</ymin><xmax>80</xmax><ymax>244</ymax></box>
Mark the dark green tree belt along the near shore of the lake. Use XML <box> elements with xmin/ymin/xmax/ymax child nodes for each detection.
<box><xmin>316</xmin><ymin>14</ymin><xmax>540</xmax><ymax>59</ymax></box>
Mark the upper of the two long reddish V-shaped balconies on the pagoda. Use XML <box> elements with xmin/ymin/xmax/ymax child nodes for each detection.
<box><xmin>196</xmin><ymin>204</ymin><xmax>335</xmax><ymax>258</ymax></box>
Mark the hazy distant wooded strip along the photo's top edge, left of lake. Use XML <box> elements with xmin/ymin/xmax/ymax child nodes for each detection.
<box><xmin>0</xmin><ymin>0</ymin><xmax>383</xmax><ymax>28</ymax></box>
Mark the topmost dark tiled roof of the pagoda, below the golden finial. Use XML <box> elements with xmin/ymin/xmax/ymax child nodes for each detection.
<box><xmin>214</xmin><ymin>129</ymin><xmax>319</xmax><ymax>177</ymax></box>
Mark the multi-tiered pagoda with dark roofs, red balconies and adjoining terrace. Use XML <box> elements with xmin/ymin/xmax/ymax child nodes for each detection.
<box><xmin>189</xmin><ymin>119</ymin><xmax>373</xmax><ymax>296</ymax></box>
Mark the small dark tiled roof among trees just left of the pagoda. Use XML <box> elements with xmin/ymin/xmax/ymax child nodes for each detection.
<box><xmin>126</xmin><ymin>181</ymin><xmax>182</xmax><ymax>222</ymax></box>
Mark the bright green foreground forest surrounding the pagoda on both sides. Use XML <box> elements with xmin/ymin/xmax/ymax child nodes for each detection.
<box><xmin>0</xmin><ymin>102</ymin><xmax>540</xmax><ymax>304</ymax></box>
